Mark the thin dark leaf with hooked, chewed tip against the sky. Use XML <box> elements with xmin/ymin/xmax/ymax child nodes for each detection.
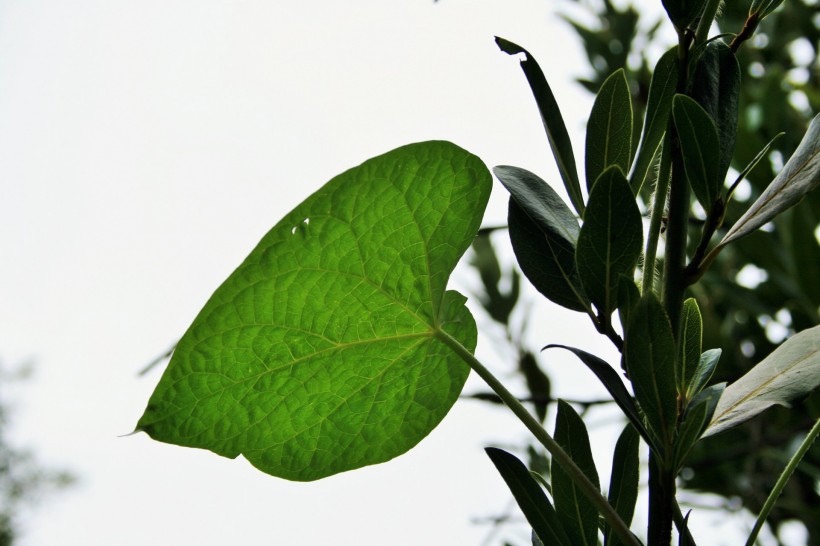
<box><xmin>495</xmin><ymin>36</ymin><xmax>584</xmax><ymax>217</ymax></box>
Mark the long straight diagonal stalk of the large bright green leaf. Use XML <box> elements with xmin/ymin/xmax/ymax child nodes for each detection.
<box><xmin>435</xmin><ymin>330</ymin><xmax>641</xmax><ymax>546</ymax></box>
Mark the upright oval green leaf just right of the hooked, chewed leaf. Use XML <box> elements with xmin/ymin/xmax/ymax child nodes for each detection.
<box><xmin>585</xmin><ymin>68</ymin><xmax>632</xmax><ymax>191</ymax></box>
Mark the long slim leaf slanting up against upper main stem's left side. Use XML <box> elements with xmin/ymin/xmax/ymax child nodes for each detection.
<box><xmin>629</xmin><ymin>47</ymin><xmax>679</xmax><ymax>195</ymax></box>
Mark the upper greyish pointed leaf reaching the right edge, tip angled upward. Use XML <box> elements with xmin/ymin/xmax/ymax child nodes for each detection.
<box><xmin>718</xmin><ymin>114</ymin><xmax>820</xmax><ymax>248</ymax></box>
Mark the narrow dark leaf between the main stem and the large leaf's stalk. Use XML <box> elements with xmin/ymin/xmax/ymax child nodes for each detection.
<box><xmin>604</xmin><ymin>425</ymin><xmax>640</xmax><ymax>546</ymax></box>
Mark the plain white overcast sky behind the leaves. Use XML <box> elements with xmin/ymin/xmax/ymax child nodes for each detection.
<box><xmin>0</xmin><ymin>0</ymin><xmax>788</xmax><ymax>546</ymax></box>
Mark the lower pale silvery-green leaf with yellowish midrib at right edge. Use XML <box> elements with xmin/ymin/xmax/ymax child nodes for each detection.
<box><xmin>704</xmin><ymin>326</ymin><xmax>820</xmax><ymax>436</ymax></box>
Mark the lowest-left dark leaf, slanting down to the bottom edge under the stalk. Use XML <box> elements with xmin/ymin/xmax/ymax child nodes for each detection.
<box><xmin>485</xmin><ymin>447</ymin><xmax>573</xmax><ymax>546</ymax></box>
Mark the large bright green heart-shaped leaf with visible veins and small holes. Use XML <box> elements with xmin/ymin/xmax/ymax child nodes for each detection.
<box><xmin>137</xmin><ymin>142</ymin><xmax>491</xmax><ymax>480</ymax></box>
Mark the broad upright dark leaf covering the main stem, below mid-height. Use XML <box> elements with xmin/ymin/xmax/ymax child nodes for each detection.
<box><xmin>624</xmin><ymin>294</ymin><xmax>677</xmax><ymax>446</ymax></box>
